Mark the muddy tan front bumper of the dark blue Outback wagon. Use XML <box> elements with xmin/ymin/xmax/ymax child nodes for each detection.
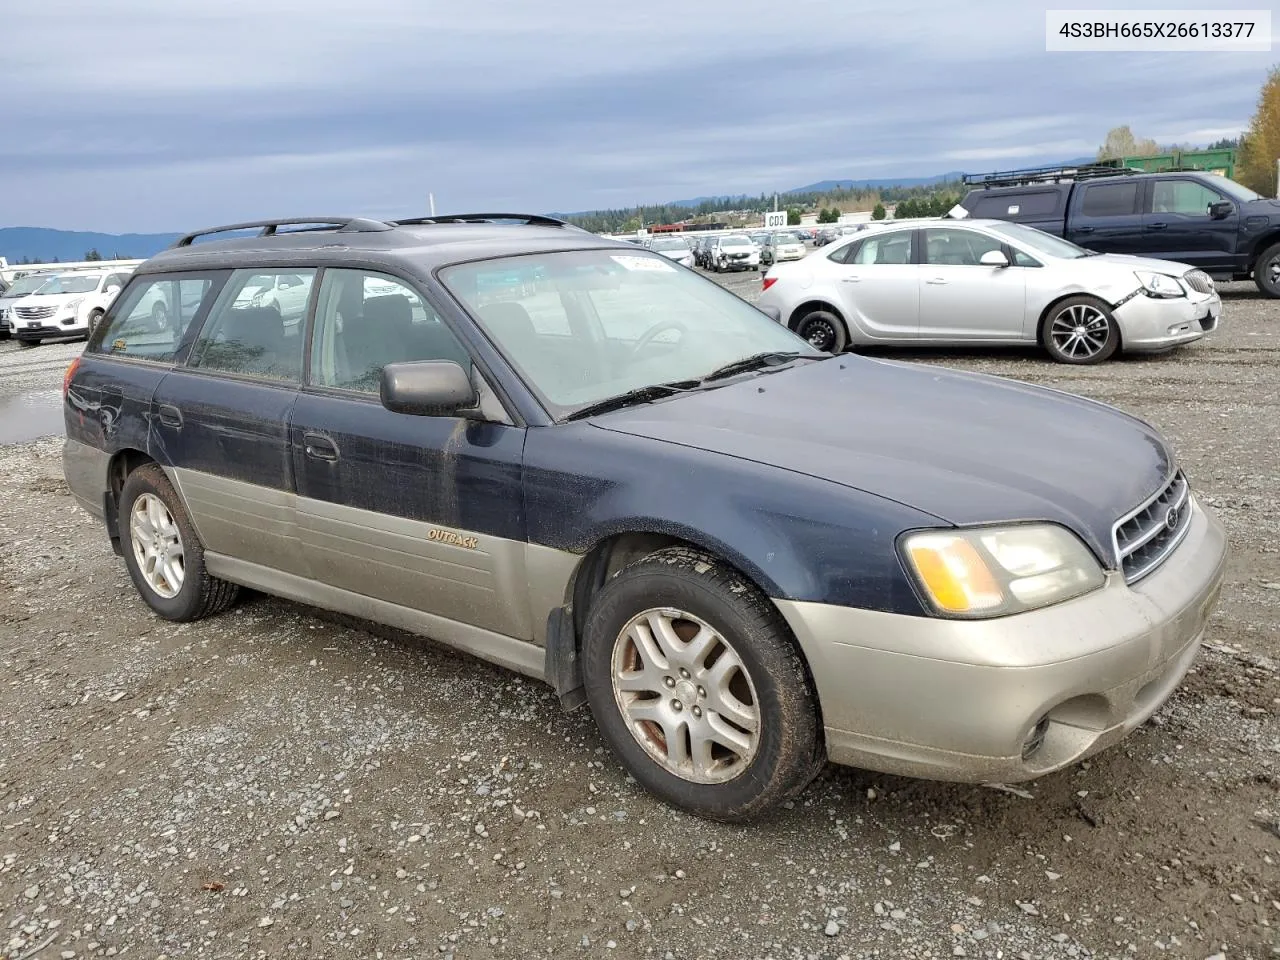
<box><xmin>774</xmin><ymin>499</ymin><xmax>1226</xmax><ymax>782</ymax></box>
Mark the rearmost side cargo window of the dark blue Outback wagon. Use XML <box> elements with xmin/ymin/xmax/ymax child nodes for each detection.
<box><xmin>84</xmin><ymin>271</ymin><xmax>227</xmax><ymax>364</ymax></box>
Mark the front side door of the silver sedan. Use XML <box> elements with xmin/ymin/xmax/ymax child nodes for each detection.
<box><xmin>919</xmin><ymin>227</ymin><xmax>1027</xmax><ymax>340</ymax></box>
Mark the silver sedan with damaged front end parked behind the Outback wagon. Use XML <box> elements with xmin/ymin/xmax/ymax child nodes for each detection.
<box><xmin>756</xmin><ymin>220</ymin><xmax>1222</xmax><ymax>364</ymax></box>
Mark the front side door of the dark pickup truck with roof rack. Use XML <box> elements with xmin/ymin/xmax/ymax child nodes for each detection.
<box><xmin>1143</xmin><ymin>177</ymin><xmax>1240</xmax><ymax>269</ymax></box>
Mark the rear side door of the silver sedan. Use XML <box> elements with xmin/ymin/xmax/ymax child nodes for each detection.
<box><xmin>832</xmin><ymin>229</ymin><xmax>920</xmax><ymax>342</ymax></box>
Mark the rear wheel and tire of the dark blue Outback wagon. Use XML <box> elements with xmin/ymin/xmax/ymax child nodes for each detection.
<box><xmin>116</xmin><ymin>463</ymin><xmax>239</xmax><ymax>622</ymax></box>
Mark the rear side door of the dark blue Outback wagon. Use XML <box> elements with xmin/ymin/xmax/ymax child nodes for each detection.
<box><xmin>151</xmin><ymin>270</ymin><xmax>316</xmax><ymax>573</ymax></box>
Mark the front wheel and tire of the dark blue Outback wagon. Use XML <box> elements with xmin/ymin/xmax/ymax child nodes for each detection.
<box><xmin>582</xmin><ymin>548</ymin><xmax>826</xmax><ymax>822</ymax></box>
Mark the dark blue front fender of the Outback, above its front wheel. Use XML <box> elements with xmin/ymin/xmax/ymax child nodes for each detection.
<box><xmin>525</xmin><ymin>422</ymin><xmax>940</xmax><ymax>616</ymax></box>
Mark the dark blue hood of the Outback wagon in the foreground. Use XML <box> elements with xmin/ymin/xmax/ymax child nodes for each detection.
<box><xmin>591</xmin><ymin>356</ymin><xmax>1172</xmax><ymax>567</ymax></box>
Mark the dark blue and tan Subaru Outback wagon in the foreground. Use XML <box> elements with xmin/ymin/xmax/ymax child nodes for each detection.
<box><xmin>65</xmin><ymin>214</ymin><xmax>1226</xmax><ymax>819</ymax></box>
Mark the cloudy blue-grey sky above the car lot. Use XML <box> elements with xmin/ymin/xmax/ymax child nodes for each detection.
<box><xmin>0</xmin><ymin>0</ymin><xmax>1280</xmax><ymax>233</ymax></box>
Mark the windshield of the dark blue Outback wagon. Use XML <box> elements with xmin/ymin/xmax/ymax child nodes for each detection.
<box><xmin>440</xmin><ymin>248</ymin><xmax>826</xmax><ymax>420</ymax></box>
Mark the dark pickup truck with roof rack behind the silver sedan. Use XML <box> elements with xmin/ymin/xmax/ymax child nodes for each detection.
<box><xmin>960</xmin><ymin>166</ymin><xmax>1280</xmax><ymax>297</ymax></box>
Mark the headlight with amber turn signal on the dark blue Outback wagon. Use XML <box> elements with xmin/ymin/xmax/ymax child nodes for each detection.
<box><xmin>902</xmin><ymin>524</ymin><xmax>1106</xmax><ymax>620</ymax></box>
